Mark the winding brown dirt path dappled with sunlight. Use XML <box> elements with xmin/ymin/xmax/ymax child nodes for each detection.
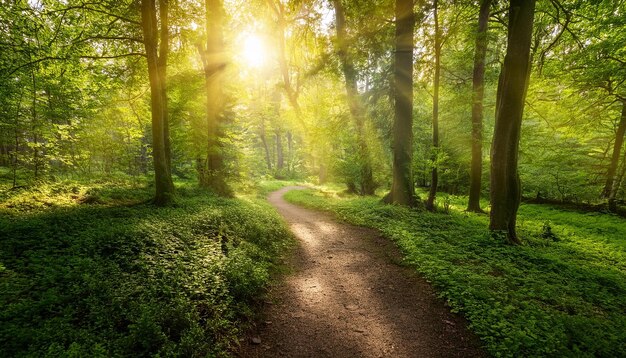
<box><xmin>239</xmin><ymin>187</ymin><xmax>485</xmax><ymax>358</ymax></box>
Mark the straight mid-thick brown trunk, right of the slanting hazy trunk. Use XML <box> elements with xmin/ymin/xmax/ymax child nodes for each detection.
<box><xmin>390</xmin><ymin>0</ymin><xmax>417</xmax><ymax>206</ymax></box>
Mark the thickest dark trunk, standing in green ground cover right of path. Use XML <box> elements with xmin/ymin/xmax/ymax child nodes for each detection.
<box><xmin>489</xmin><ymin>0</ymin><xmax>535</xmax><ymax>244</ymax></box>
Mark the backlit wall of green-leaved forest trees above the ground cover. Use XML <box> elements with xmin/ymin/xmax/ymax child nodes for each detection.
<box><xmin>0</xmin><ymin>0</ymin><xmax>626</xmax><ymax>220</ymax></box>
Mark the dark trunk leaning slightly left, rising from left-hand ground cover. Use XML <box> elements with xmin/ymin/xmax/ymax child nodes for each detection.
<box><xmin>141</xmin><ymin>0</ymin><xmax>174</xmax><ymax>205</ymax></box>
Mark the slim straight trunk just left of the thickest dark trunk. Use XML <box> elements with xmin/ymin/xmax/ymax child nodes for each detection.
<box><xmin>467</xmin><ymin>0</ymin><xmax>493</xmax><ymax>213</ymax></box>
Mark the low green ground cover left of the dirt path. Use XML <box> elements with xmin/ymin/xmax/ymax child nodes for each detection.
<box><xmin>0</xmin><ymin>180</ymin><xmax>293</xmax><ymax>357</ymax></box>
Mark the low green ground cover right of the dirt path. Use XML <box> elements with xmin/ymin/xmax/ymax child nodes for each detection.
<box><xmin>286</xmin><ymin>190</ymin><xmax>626</xmax><ymax>357</ymax></box>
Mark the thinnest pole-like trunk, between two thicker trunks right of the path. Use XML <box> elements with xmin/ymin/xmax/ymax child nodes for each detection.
<box><xmin>426</xmin><ymin>0</ymin><xmax>441</xmax><ymax>211</ymax></box>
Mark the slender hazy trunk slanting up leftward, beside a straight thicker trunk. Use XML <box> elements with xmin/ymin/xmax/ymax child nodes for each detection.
<box><xmin>333</xmin><ymin>0</ymin><xmax>376</xmax><ymax>195</ymax></box>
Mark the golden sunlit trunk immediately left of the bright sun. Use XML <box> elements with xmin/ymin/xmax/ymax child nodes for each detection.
<box><xmin>201</xmin><ymin>0</ymin><xmax>232</xmax><ymax>196</ymax></box>
